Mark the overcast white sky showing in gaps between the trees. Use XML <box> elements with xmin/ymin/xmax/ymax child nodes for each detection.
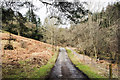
<box><xmin>20</xmin><ymin>0</ymin><xmax>120</xmax><ymax>27</ymax></box>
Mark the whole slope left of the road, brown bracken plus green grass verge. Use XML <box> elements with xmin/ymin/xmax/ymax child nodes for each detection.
<box><xmin>1</xmin><ymin>31</ymin><xmax>58</xmax><ymax>79</ymax></box>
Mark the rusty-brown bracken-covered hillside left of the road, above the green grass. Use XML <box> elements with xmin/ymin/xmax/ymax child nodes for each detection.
<box><xmin>0</xmin><ymin>33</ymin><xmax>54</xmax><ymax>77</ymax></box>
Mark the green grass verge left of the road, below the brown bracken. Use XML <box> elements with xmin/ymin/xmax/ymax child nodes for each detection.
<box><xmin>2</xmin><ymin>49</ymin><xmax>58</xmax><ymax>80</ymax></box>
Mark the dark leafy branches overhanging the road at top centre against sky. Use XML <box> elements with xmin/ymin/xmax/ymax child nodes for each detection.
<box><xmin>40</xmin><ymin>0</ymin><xmax>89</xmax><ymax>23</ymax></box>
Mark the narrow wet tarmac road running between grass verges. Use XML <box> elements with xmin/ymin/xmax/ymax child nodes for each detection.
<box><xmin>47</xmin><ymin>48</ymin><xmax>89</xmax><ymax>80</ymax></box>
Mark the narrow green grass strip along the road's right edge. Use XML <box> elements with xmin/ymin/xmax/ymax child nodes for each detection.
<box><xmin>66</xmin><ymin>49</ymin><xmax>105</xmax><ymax>80</ymax></box>
